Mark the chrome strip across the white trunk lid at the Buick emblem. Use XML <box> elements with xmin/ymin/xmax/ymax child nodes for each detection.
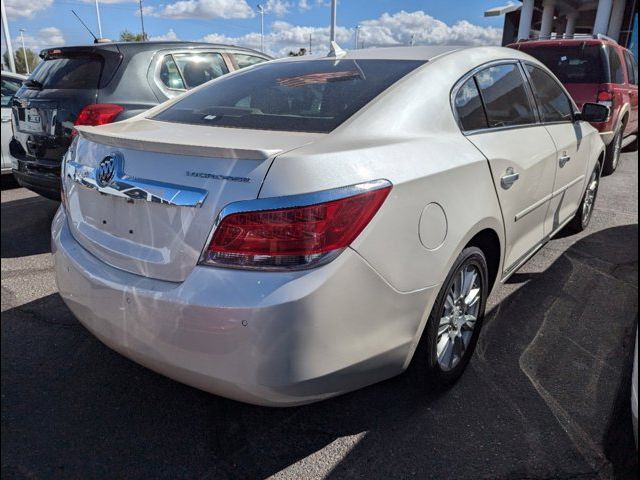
<box><xmin>64</xmin><ymin>158</ymin><xmax>208</xmax><ymax>207</ymax></box>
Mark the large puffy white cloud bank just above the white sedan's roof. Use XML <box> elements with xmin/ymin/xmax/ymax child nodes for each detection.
<box><xmin>359</xmin><ymin>10</ymin><xmax>502</xmax><ymax>47</ymax></box>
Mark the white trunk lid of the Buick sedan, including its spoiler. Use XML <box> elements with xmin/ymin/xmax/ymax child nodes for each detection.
<box><xmin>64</xmin><ymin>119</ymin><xmax>322</xmax><ymax>282</ymax></box>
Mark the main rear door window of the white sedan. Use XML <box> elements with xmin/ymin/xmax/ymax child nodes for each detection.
<box><xmin>475</xmin><ymin>64</ymin><xmax>536</xmax><ymax>127</ymax></box>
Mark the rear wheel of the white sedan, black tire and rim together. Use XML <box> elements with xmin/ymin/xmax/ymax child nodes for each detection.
<box><xmin>412</xmin><ymin>247</ymin><xmax>489</xmax><ymax>390</ymax></box>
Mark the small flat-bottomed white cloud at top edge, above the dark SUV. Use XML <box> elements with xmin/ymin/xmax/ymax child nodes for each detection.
<box><xmin>148</xmin><ymin>0</ymin><xmax>255</xmax><ymax>19</ymax></box>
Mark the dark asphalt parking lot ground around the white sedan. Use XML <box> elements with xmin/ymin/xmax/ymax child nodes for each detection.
<box><xmin>1</xmin><ymin>153</ymin><xmax>638</xmax><ymax>479</ymax></box>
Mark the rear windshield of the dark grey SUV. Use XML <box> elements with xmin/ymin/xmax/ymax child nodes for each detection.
<box><xmin>29</xmin><ymin>55</ymin><xmax>103</xmax><ymax>90</ymax></box>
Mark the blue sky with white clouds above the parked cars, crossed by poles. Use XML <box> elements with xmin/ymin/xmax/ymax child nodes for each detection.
<box><xmin>2</xmin><ymin>0</ymin><xmax>508</xmax><ymax>55</ymax></box>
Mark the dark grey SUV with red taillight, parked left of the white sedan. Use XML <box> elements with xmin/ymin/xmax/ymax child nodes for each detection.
<box><xmin>10</xmin><ymin>42</ymin><xmax>270</xmax><ymax>199</ymax></box>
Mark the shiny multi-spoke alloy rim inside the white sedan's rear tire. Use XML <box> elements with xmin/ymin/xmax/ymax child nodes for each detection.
<box><xmin>436</xmin><ymin>264</ymin><xmax>482</xmax><ymax>371</ymax></box>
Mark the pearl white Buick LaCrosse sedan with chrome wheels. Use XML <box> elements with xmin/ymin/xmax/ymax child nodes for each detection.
<box><xmin>52</xmin><ymin>47</ymin><xmax>608</xmax><ymax>406</ymax></box>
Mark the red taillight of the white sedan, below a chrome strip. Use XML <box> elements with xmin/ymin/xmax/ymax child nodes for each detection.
<box><xmin>202</xmin><ymin>180</ymin><xmax>391</xmax><ymax>270</ymax></box>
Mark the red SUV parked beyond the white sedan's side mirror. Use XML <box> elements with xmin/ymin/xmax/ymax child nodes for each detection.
<box><xmin>509</xmin><ymin>38</ymin><xmax>638</xmax><ymax>175</ymax></box>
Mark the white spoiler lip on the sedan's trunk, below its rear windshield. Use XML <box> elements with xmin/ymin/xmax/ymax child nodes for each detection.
<box><xmin>76</xmin><ymin>118</ymin><xmax>326</xmax><ymax>160</ymax></box>
